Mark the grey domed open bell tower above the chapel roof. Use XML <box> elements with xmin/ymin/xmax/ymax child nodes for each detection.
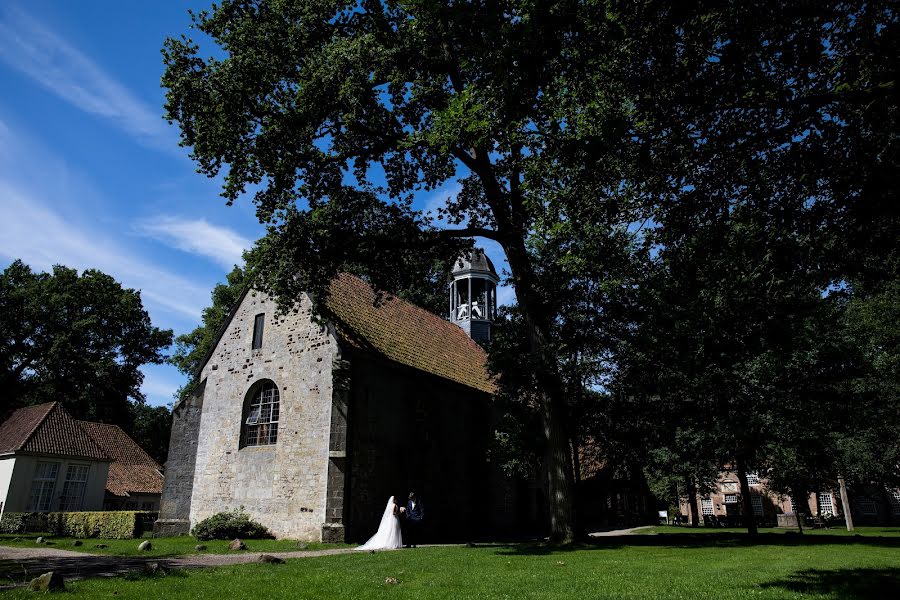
<box><xmin>450</xmin><ymin>248</ymin><xmax>500</xmax><ymax>344</ymax></box>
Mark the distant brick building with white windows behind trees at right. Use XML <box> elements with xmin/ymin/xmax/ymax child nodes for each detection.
<box><xmin>681</xmin><ymin>471</ymin><xmax>900</xmax><ymax>526</ymax></box>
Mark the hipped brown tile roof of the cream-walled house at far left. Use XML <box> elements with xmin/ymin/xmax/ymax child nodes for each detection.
<box><xmin>0</xmin><ymin>402</ymin><xmax>109</xmax><ymax>460</ymax></box>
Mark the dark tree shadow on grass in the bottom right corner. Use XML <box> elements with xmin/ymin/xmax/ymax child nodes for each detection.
<box><xmin>760</xmin><ymin>568</ymin><xmax>900</xmax><ymax>600</ymax></box>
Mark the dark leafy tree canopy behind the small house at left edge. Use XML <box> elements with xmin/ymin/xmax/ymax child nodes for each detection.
<box><xmin>0</xmin><ymin>260</ymin><xmax>172</xmax><ymax>428</ymax></box>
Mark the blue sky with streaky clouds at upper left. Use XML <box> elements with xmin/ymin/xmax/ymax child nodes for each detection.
<box><xmin>0</xmin><ymin>0</ymin><xmax>511</xmax><ymax>404</ymax></box>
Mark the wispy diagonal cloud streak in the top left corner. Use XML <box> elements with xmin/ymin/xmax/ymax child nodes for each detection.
<box><xmin>0</xmin><ymin>6</ymin><xmax>178</xmax><ymax>151</ymax></box>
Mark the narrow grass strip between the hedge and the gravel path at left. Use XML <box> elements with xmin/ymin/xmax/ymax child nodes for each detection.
<box><xmin>0</xmin><ymin>533</ymin><xmax>341</xmax><ymax>558</ymax></box>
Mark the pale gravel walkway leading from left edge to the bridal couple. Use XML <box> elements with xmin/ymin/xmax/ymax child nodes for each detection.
<box><xmin>0</xmin><ymin>527</ymin><xmax>640</xmax><ymax>589</ymax></box>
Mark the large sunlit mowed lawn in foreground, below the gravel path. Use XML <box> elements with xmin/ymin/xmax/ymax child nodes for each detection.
<box><xmin>5</xmin><ymin>532</ymin><xmax>900</xmax><ymax>600</ymax></box>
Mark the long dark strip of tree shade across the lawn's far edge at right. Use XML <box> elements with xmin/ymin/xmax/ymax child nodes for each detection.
<box><xmin>498</xmin><ymin>533</ymin><xmax>900</xmax><ymax>555</ymax></box>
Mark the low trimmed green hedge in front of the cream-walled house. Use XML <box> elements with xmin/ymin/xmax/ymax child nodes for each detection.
<box><xmin>0</xmin><ymin>510</ymin><xmax>155</xmax><ymax>540</ymax></box>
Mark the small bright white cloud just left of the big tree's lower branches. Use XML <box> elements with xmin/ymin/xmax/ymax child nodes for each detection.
<box><xmin>136</xmin><ymin>216</ymin><xmax>253</xmax><ymax>269</ymax></box>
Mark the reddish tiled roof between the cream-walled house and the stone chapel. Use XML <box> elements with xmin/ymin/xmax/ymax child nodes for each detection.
<box><xmin>78</xmin><ymin>421</ymin><xmax>163</xmax><ymax>497</ymax></box>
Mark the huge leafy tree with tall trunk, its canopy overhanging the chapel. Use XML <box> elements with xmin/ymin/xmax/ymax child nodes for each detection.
<box><xmin>163</xmin><ymin>0</ymin><xmax>898</xmax><ymax>540</ymax></box>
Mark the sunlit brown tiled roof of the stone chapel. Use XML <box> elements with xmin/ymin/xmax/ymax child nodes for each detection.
<box><xmin>325</xmin><ymin>274</ymin><xmax>496</xmax><ymax>394</ymax></box>
